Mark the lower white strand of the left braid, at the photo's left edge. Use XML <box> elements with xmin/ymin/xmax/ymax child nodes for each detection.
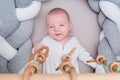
<box><xmin>0</xmin><ymin>36</ymin><xmax>17</xmax><ymax>60</ymax></box>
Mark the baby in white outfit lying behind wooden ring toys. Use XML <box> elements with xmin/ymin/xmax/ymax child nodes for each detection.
<box><xmin>34</xmin><ymin>8</ymin><xmax>96</xmax><ymax>74</ymax></box>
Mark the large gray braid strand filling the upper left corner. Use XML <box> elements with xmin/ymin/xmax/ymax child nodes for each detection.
<box><xmin>0</xmin><ymin>0</ymin><xmax>19</xmax><ymax>38</ymax></box>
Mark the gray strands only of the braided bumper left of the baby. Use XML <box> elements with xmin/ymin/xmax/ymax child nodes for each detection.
<box><xmin>0</xmin><ymin>0</ymin><xmax>40</xmax><ymax>73</ymax></box>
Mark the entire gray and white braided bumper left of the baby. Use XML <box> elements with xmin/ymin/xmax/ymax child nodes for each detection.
<box><xmin>0</xmin><ymin>0</ymin><xmax>41</xmax><ymax>73</ymax></box>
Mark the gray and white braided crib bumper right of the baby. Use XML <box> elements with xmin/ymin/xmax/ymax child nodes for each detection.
<box><xmin>88</xmin><ymin>0</ymin><xmax>120</xmax><ymax>72</ymax></box>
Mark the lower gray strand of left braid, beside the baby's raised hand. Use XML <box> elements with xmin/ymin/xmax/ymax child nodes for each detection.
<box><xmin>8</xmin><ymin>39</ymin><xmax>32</xmax><ymax>73</ymax></box>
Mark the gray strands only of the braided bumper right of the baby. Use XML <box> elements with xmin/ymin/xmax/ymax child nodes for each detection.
<box><xmin>88</xmin><ymin>0</ymin><xmax>120</xmax><ymax>73</ymax></box>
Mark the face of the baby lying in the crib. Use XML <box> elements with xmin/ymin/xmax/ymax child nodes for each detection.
<box><xmin>46</xmin><ymin>13</ymin><xmax>72</xmax><ymax>41</ymax></box>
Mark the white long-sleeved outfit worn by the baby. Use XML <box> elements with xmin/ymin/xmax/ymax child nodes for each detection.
<box><xmin>38</xmin><ymin>35</ymin><xmax>96</xmax><ymax>74</ymax></box>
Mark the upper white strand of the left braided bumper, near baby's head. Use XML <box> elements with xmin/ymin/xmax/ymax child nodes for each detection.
<box><xmin>16</xmin><ymin>1</ymin><xmax>41</xmax><ymax>21</ymax></box>
